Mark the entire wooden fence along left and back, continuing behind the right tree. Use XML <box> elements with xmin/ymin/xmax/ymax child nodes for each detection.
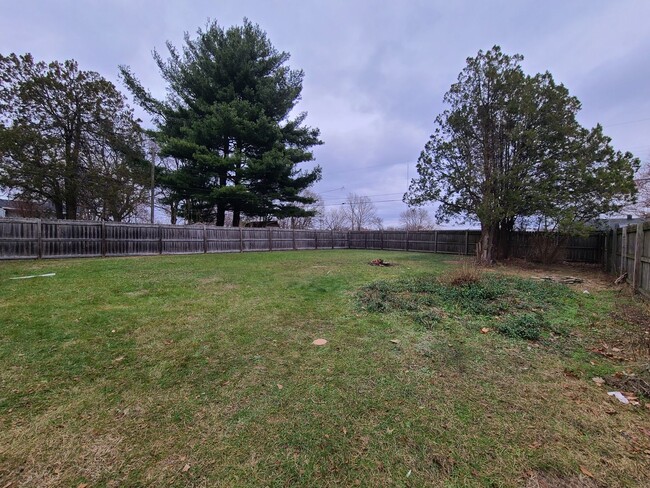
<box><xmin>0</xmin><ymin>219</ymin><xmax>604</xmax><ymax>263</ymax></box>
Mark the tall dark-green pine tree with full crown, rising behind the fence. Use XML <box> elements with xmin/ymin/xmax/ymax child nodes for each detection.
<box><xmin>121</xmin><ymin>20</ymin><xmax>321</xmax><ymax>226</ymax></box>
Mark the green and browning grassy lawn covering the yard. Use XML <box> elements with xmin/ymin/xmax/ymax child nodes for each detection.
<box><xmin>0</xmin><ymin>251</ymin><xmax>650</xmax><ymax>487</ymax></box>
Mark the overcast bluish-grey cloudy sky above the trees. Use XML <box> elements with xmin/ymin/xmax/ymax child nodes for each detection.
<box><xmin>0</xmin><ymin>0</ymin><xmax>650</xmax><ymax>225</ymax></box>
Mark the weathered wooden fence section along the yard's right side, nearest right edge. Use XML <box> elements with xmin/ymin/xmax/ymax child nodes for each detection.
<box><xmin>604</xmin><ymin>222</ymin><xmax>650</xmax><ymax>299</ymax></box>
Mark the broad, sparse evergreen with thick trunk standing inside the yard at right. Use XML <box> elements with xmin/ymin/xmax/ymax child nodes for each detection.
<box><xmin>405</xmin><ymin>46</ymin><xmax>639</xmax><ymax>263</ymax></box>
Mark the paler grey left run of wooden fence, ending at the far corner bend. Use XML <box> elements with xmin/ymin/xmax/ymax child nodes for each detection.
<box><xmin>0</xmin><ymin>219</ymin><xmax>348</xmax><ymax>259</ymax></box>
